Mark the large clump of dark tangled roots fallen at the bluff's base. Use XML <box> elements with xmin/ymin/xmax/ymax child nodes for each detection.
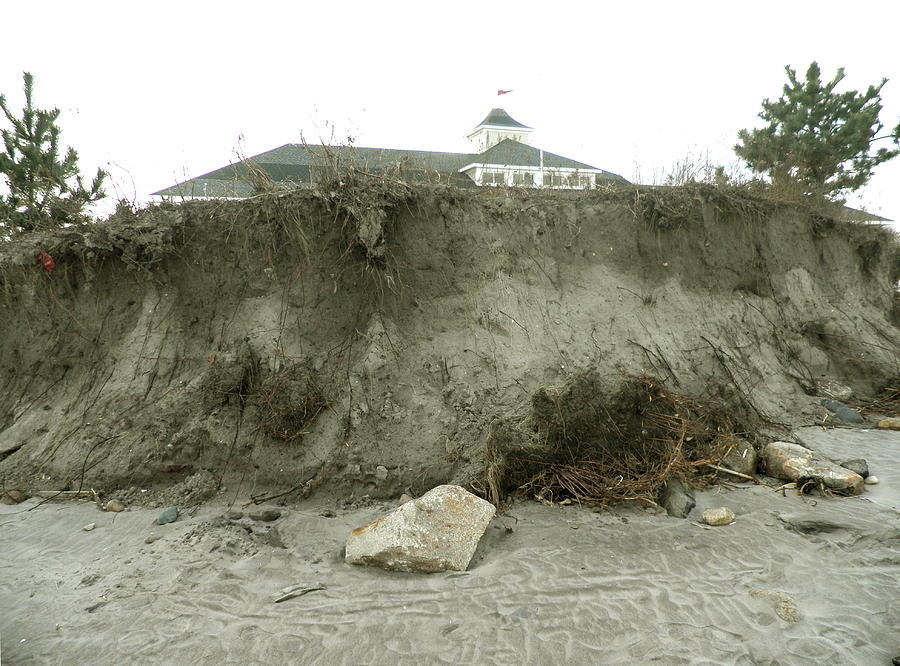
<box><xmin>485</xmin><ymin>372</ymin><xmax>748</xmax><ymax>506</ymax></box>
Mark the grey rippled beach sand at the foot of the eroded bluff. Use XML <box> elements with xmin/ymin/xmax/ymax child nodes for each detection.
<box><xmin>0</xmin><ymin>428</ymin><xmax>900</xmax><ymax>664</ymax></box>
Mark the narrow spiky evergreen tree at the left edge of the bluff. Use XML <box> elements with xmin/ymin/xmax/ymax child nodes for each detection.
<box><xmin>0</xmin><ymin>72</ymin><xmax>106</xmax><ymax>231</ymax></box>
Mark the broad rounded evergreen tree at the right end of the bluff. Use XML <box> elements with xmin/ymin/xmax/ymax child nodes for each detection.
<box><xmin>734</xmin><ymin>62</ymin><xmax>900</xmax><ymax>198</ymax></box>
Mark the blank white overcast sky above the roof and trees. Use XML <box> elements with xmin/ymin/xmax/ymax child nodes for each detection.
<box><xmin>0</xmin><ymin>0</ymin><xmax>900</xmax><ymax>226</ymax></box>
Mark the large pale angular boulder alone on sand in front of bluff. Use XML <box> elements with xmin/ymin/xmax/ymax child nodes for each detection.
<box><xmin>345</xmin><ymin>486</ymin><xmax>496</xmax><ymax>573</ymax></box>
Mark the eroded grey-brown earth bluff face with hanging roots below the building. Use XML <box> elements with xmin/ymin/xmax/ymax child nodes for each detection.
<box><xmin>0</xmin><ymin>178</ymin><xmax>900</xmax><ymax>497</ymax></box>
